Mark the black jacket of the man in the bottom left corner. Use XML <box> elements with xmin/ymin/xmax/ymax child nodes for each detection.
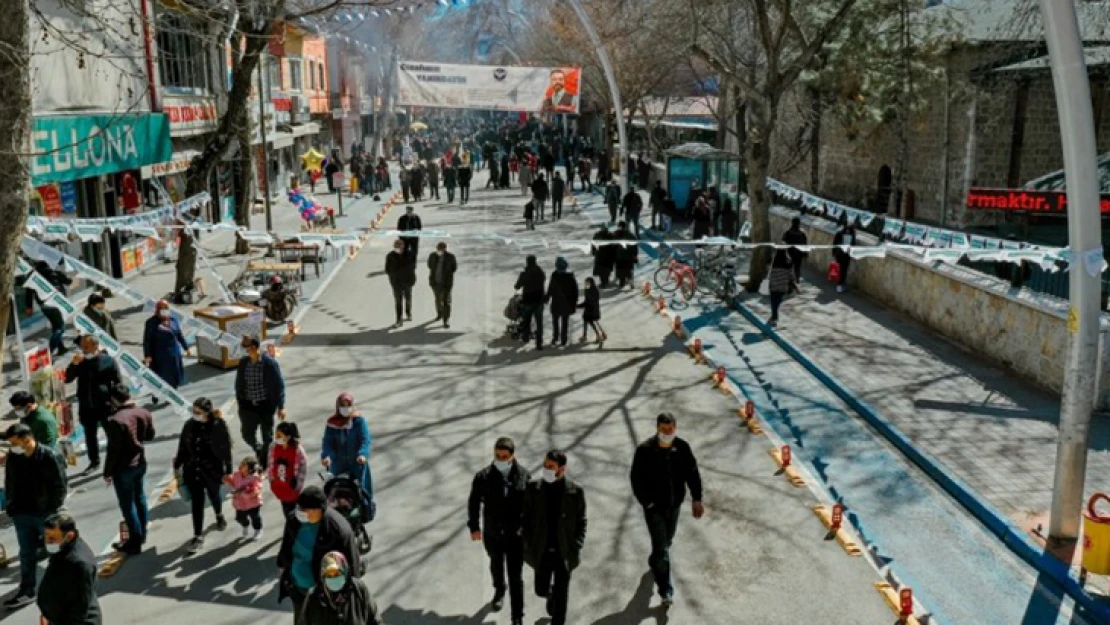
<box><xmin>37</xmin><ymin>536</ymin><xmax>100</xmax><ymax>625</ymax></box>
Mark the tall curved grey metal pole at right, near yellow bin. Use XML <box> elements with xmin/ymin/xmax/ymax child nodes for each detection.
<box><xmin>1040</xmin><ymin>0</ymin><xmax>1102</xmax><ymax>541</ymax></box>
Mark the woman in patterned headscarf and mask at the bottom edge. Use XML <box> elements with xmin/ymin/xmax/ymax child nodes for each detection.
<box><xmin>299</xmin><ymin>552</ymin><xmax>382</xmax><ymax>625</ymax></box>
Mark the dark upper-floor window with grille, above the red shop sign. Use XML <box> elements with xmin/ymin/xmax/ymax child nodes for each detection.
<box><xmin>157</xmin><ymin>11</ymin><xmax>214</xmax><ymax>92</ymax></box>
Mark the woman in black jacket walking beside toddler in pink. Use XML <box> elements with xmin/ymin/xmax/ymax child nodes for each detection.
<box><xmin>173</xmin><ymin>397</ymin><xmax>232</xmax><ymax>555</ymax></box>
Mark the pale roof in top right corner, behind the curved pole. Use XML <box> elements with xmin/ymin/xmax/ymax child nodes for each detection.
<box><xmin>928</xmin><ymin>0</ymin><xmax>1110</xmax><ymax>43</ymax></box>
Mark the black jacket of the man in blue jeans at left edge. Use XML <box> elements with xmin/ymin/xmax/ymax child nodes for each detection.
<box><xmin>3</xmin><ymin>444</ymin><xmax>67</xmax><ymax>518</ymax></box>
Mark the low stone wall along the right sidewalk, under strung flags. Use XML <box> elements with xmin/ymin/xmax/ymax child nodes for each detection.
<box><xmin>770</xmin><ymin>206</ymin><xmax>1110</xmax><ymax>410</ymax></box>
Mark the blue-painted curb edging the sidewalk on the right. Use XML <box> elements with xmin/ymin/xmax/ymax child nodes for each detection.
<box><xmin>642</xmin><ymin>230</ymin><xmax>1110</xmax><ymax>625</ymax></box>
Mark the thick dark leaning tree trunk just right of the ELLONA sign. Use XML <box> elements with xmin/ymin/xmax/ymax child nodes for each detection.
<box><xmin>173</xmin><ymin>26</ymin><xmax>272</xmax><ymax>293</ymax></box>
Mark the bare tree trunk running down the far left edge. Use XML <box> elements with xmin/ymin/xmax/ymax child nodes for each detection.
<box><xmin>0</xmin><ymin>0</ymin><xmax>31</xmax><ymax>382</ymax></box>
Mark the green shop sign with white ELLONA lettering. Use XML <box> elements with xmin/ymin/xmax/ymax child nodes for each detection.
<box><xmin>31</xmin><ymin>113</ymin><xmax>173</xmax><ymax>187</ymax></box>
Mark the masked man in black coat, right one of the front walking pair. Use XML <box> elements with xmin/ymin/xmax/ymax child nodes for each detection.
<box><xmin>522</xmin><ymin>450</ymin><xmax>586</xmax><ymax>625</ymax></box>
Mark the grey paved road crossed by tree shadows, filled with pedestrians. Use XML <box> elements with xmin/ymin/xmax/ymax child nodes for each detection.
<box><xmin>0</xmin><ymin>173</ymin><xmax>891</xmax><ymax>625</ymax></box>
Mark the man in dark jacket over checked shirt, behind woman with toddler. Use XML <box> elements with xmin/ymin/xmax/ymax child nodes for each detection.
<box><xmin>235</xmin><ymin>336</ymin><xmax>285</xmax><ymax>468</ymax></box>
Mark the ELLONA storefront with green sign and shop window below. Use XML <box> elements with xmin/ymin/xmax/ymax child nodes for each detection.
<box><xmin>30</xmin><ymin>113</ymin><xmax>172</xmax><ymax>278</ymax></box>
